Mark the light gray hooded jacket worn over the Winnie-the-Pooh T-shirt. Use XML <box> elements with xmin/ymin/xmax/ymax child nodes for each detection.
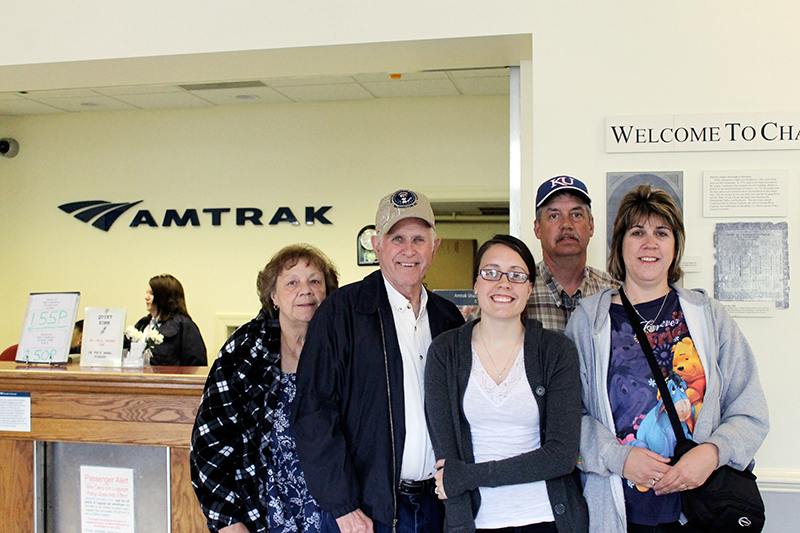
<box><xmin>566</xmin><ymin>286</ymin><xmax>769</xmax><ymax>533</ymax></box>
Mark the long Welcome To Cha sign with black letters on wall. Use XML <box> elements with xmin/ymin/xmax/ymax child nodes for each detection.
<box><xmin>606</xmin><ymin>113</ymin><xmax>800</xmax><ymax>153</ymax></box>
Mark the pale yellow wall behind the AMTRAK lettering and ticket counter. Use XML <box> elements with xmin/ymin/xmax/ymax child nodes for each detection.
<box><xmin>0</xmin><ymin>96</ymin><xmax>508</xmax><ymax>356</ymax></box>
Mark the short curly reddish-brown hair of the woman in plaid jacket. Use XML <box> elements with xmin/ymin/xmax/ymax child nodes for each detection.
<box><xmin>256</xmin><ymin>243</ymin><xmax>339</xmax><ymax>318</ymax></box>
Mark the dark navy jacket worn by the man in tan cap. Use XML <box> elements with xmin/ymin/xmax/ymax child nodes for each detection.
<box><xmin>292</xmin><ymin>271</ymin><xmax>464</xmax><ymax>525</ymax></box>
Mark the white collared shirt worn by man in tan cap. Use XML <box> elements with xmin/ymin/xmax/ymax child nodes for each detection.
<box><xmin>383</xmin><ymin>277</ymin><xmax>436</xmax><ymax>481</ymax></box>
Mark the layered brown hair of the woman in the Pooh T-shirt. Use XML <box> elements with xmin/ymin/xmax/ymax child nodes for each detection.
<box><xmin>608</xmin><ymin>185</ymin><xmax>686</xmax><ymax>283</ymax></box>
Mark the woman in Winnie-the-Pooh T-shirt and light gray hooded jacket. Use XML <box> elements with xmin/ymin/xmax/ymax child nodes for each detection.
<box><xmin>566</xmin><ymin>185</ymin><xmax>769</xmax><ymax>533</ymax></box>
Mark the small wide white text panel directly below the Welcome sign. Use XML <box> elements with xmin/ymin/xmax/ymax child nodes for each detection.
<box><xmin>703</xmin><ymin>170</ymin><xmax>789</xmax><ymax>218</ymax></box>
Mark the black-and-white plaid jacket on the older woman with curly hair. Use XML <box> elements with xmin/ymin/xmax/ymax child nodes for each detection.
<box><xmin>191</xmin><ymin>310</ymin><xmax>281</xmax><ymax>532</ymax></box>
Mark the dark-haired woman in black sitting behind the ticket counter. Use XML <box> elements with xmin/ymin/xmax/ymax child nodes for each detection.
<box><xmin>134</xmin><ymin>274</ymin><xmax>208</xmax><ymax>366</ymax></box>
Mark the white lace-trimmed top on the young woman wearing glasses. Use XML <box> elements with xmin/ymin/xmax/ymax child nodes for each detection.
<box><xmin>464</xmin><ymin>346</ymin><xmax>554</xmax><ymax>529</ymax></box>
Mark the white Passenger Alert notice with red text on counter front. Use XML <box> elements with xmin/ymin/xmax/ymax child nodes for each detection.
<box><xmin>81</xmin><ymin>466</ymin><xmax>134</xmax><ymax>533</ymax></box>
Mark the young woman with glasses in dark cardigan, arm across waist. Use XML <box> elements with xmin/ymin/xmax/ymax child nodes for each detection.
<box><xmin>425</xmin><ymin>235</ymin><xmax>588</xmax><ymax>533</ymax></box>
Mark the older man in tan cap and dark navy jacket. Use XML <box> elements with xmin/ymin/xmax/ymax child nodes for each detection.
<box><xmin>292</xmin><ymin>190</ymin><xmax>464</xmax><ymax>533</ymax></box>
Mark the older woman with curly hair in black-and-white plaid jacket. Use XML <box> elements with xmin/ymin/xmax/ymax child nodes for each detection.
<box><xmin>191</xmin><ymin>244</ymin><xmax>339</xmax><ymax>533</ymax></box>
